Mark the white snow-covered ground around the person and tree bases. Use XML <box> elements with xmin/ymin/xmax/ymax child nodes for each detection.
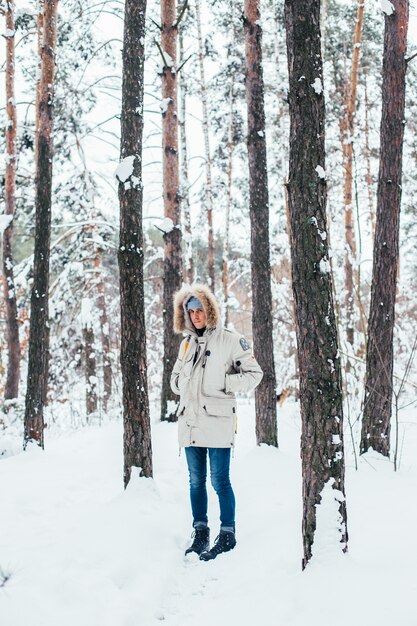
<box><xmin>0</xmin><ymin>403</ymin><xmax>417</xmax><ymax>626</ymax></box>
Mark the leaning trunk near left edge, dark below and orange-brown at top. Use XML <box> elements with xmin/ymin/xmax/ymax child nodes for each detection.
<box><xmin>24</xmin><ymin>0</ymin><xmax>58</xmax><ymax>447</ymax></box>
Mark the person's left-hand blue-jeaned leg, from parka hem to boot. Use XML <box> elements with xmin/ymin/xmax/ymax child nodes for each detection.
<box><xmin>185</xmin><ymin>446</ymin><xmax>208</xmax><ymax>528</ymax></box>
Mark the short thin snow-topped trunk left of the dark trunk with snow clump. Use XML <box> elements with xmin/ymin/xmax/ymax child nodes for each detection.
<box><xmin>81</xmin><ymin>298</ymin><xmax>98</xmax><ymax>423</ymax></box>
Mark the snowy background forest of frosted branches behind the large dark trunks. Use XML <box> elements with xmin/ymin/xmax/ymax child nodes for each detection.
<box><xmin>0</xmin><ymin>0</ymin><xmax>417</xmax><ymax>616</ymax></box>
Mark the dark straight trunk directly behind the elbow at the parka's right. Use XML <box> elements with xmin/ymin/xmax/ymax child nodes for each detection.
<box><xmin>244</xmin><ymin>0</ymin><xmax>278</xmax><ymax>446</ymax></box>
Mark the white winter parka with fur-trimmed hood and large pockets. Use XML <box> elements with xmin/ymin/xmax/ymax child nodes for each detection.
<box><xmin>171</xmin><ymin>284</ymin><xmax>263</xmax><ymax>448</ymax></box>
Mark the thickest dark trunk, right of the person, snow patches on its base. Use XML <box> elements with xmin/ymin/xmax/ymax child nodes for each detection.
<box><xmin>285</xmin><ymin>0</ymin><xmax>347</xmax><ymax>567</ymax></box>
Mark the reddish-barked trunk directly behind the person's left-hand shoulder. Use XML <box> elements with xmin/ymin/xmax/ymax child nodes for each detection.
<box><xmin>161</xmin><ymin>0</ymin><xmax>182</xmax><ymax>422</ymax></box>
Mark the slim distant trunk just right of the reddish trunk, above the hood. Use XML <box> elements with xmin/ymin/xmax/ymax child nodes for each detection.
<box><xmin>178</xmin><ymin>28</ymin><xmax>194</xmax><ymax>284</ymax></box>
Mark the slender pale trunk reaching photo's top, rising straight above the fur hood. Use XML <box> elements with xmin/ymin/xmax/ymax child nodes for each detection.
<box><xmin>195</xmin><ymin>0</ymin><xmax>215</xmax><ymax>292</ymax></box>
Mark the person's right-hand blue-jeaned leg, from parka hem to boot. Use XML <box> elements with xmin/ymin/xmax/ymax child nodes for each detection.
<box><xmin>208</xmin><ymin>448</ymin><xmax>236</xmax><ymax>532</ymax></box>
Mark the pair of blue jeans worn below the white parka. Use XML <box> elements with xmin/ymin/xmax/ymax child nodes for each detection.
<box><xmin>185</xmin><ymin>447</ymin><xmax>235</xmax><ymax>531</ymax></box>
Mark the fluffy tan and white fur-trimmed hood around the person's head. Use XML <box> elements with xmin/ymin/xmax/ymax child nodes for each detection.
<box><xmin>174</xmin><ymin>283</ymin><xmax>221</xmax><ymax>333</ymax></box>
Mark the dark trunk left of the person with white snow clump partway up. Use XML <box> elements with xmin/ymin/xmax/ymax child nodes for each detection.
<box><xmin>117</xmin><ymin>0</ymin><xmax>152</xmax><ymax>487</ymax></box>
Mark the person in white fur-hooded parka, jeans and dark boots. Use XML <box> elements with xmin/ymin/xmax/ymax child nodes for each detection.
<box><xmin>171</xmin><ymin>283</ymin><xmax>263</xmax><ymax>561</ymax></box>
